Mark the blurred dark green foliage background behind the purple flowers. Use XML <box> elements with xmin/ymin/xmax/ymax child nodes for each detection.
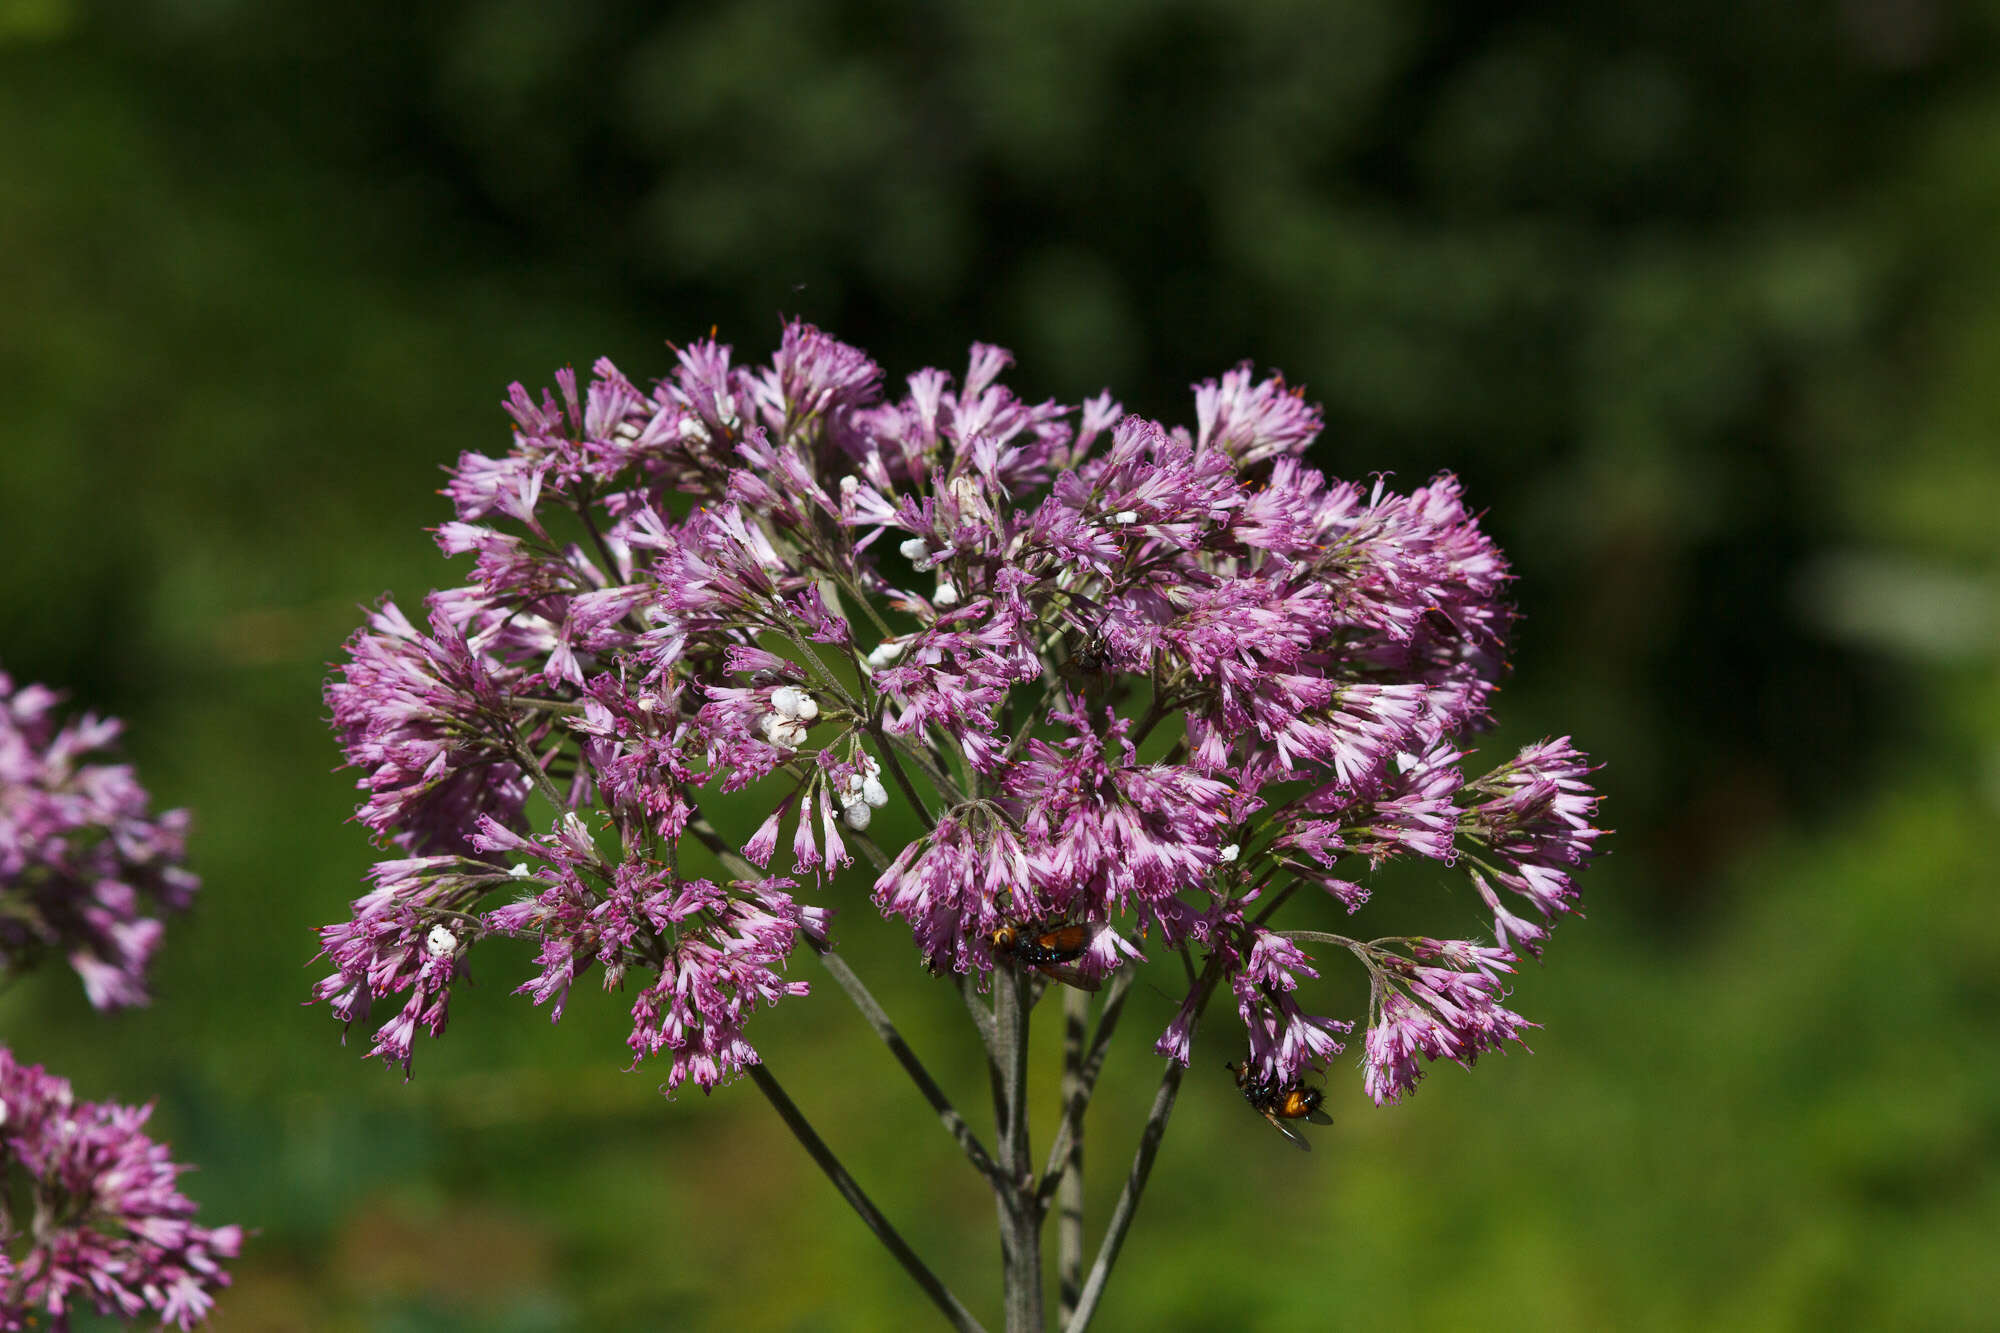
<box><xmin>0</xmin><ymin>0</ymin><xmax>2000</xmax><ymax>1331</ymax></box>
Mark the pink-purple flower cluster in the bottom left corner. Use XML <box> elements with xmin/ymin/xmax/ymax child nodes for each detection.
<box><xmin>0</xmin><ymin>1047</ymin><xmax>242</xmax><ymax>1333</ymax></box>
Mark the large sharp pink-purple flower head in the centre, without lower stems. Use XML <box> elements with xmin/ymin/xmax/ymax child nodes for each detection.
<box><xmin>316</xmin><ymin>324</ymin><xmax>1598</xmax><ymax>1101</ymax></box>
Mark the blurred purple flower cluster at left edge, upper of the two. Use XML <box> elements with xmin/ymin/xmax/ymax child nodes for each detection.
<box><xmin>0</xmin><ymin>673</ymin><xmax>200</xmax><ymax>1009</ymax></box>
